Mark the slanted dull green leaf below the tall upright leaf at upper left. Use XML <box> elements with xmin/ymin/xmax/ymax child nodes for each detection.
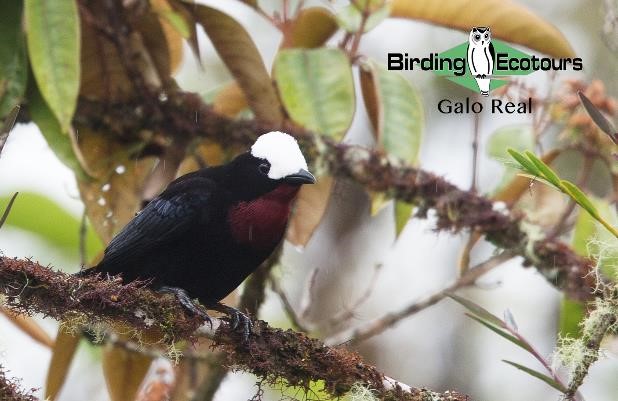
<box><xmin>28</xmin><ymin>80</ymin><xmax>88</xmax><ymax>177</ymax></box>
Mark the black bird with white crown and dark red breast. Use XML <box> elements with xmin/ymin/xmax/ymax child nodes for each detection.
<box><xmin>77</xmin><ymin>131</ymin><xmax>316</xmax><ymax>338</ymax></box>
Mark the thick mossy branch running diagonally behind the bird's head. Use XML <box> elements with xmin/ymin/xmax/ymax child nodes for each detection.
<box><xmin>75</xmin><ymin>91</ymin><xmax>597</xmax><ymax>300</ymax></box>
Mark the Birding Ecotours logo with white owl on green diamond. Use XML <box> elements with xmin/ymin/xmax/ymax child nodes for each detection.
<box><xmin>387</xmin><ymin>26</ymin><xmax>583</xmax><ymax>101</ymax></box>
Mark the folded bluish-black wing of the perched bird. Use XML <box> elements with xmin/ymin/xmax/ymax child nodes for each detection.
<box><xmin>99</xmin><ymin>176</ymin><xmax>215</xmax><ymax>268</ymax></box>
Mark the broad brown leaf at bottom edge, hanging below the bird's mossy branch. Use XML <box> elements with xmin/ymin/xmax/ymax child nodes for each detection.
<box><xmin>103</xmin><ymin>346</ymin><xmax>152</xmax><ymax>401</ymax></box>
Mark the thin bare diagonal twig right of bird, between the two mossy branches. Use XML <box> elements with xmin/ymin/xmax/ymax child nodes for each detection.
<box><xmin>324</xmin><ymin>251</ymin><xmax>515</xmax><ymax>346</ymax></box>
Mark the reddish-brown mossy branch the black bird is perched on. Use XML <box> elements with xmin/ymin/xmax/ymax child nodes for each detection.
<box><xmin>0</xmin><ymin>257</ymin><xmax>469</xmax><ymax>401</ymax></box>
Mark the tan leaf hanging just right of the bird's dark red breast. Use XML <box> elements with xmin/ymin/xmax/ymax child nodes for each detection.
<box><xmin>286</xmin><ymin>177</ymin><xmax>334</xmax><ymax>247</ymax></box>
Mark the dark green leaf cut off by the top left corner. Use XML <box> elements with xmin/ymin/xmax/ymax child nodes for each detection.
<box><xmin>0</xmin><ymin>1</ymin><xmax>28</xmax><ymax>118</ymax></box>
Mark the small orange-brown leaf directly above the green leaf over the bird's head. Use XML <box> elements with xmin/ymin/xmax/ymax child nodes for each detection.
<box><xmin>281</xmin><ymin>7</ymin><xmax>337</xmax><ymax>49</ymax></box>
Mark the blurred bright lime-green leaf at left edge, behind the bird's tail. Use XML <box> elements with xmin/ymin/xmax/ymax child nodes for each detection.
<box><xmin>0</xmin><ymin>192</ymin><xmax>102</xmax><ymax>260</ymax></box>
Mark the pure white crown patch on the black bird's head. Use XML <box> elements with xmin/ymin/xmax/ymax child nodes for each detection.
<box><xmin>251</xmin><ymin>131</ymin><xmax>307</xmax><ymax>180</ymax></box>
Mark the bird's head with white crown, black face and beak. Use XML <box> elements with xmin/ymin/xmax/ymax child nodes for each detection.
<box><xmin>226</xmin><ymin>131</ymin><xmax>315</xmax><ymax>199</ymax></box>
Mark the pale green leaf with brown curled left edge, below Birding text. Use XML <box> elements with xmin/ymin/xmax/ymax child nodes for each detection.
<box><xmin>361</xmin><ymin>61</ymin><xmax>425</xmax><ymax>164</ymax></box>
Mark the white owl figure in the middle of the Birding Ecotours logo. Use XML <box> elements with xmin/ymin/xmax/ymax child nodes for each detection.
<box><xmin>468</xmin><ymin>26</ymin><xmax>495</xmax><ymax>96</ymax></box>
